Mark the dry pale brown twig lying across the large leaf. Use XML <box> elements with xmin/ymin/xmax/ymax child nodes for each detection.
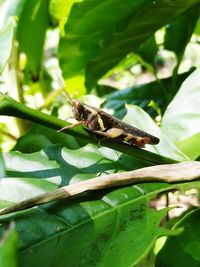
<box><xmin>0</xmin><ymin>161</ymin><xmax>200</xmax><ymax>215</ymax></box>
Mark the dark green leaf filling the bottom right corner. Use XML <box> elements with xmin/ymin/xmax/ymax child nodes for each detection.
<box><xmin>156</xmin><ymin>209</ymin><xmax>200</xmax><ymax>267</ymax></box>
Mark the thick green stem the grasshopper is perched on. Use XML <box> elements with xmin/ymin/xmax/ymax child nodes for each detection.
<box><xmin>0</xmin><ymin>95</ymin><xmax>176</xmax><ymax>164</ymax></box>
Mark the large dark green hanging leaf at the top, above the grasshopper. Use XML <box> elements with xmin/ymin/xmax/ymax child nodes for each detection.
<box><xmin>58</xmin><ymin>0</ymin><xmax>199</xmax><ymax>89</ymax></box>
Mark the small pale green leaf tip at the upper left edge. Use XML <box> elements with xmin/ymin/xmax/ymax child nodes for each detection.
<box><xmin>0</xmin><ymin>18</ymin><xmax>15</xmax><ymax>74</ymax></box>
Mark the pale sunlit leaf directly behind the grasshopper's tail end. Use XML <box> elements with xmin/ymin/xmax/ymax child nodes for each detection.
<box><xmin>124</xmin><ymin>105</ymin><xmax>189</xmax><ymax>161</ymax></box>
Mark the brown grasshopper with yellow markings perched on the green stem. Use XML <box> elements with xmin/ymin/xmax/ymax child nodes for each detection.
<box><xmin>56</xmin><ymin>76</ymin><xmax>160</xmax><ymax>148</ymax></box>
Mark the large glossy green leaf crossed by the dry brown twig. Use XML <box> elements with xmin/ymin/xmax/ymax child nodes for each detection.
<box><xmin>0</xmin><ymin>145</ymin><xmax>199</xmax><ymax>267</ymax></box>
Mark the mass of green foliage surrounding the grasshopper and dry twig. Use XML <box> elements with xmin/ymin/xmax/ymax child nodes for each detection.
<box><xmin>0</xmin><ymin>0</ymin><xmax>200</xmax><ymax>267</ymax></box>
